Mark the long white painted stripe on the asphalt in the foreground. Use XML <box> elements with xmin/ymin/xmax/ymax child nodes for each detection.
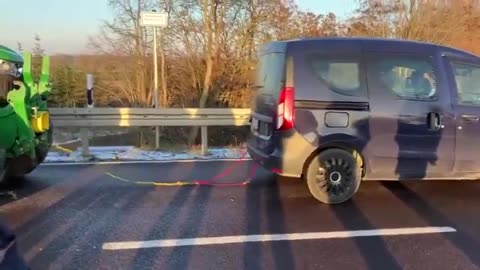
<box><xmin>102</xmin><ymin>227</ymin><xmax>457</xmax><ymax>250</ymax></box>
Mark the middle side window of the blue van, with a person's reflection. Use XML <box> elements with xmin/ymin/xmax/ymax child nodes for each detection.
<box><xmin>370</xmin><ymin>56</ymin><xmax>437</xmax><ymax>101</ymax></box>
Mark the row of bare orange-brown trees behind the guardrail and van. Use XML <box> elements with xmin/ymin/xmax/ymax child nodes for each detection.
<box><xmin>49</xmin><ymin>0</ymin><xmax>480</xmax><ymax>149</ymax></box>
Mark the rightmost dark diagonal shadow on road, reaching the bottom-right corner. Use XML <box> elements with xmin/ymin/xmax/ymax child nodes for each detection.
<box><xmin>382</xmin><ymin>182</ymin><xmax>480</xmax><ymax>267</ymax></box>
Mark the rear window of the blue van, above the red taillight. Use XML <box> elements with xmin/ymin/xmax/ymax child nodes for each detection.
<box><xmin>256</xmin><ymin>53</ymin><xmax>285</xmax><ymax>96</ymax></box>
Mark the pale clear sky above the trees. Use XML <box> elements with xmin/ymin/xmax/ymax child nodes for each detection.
<box><xmin>0</xmin><ymin>0</ymin><xmax>357</xmax><ymax>54</ymax></box>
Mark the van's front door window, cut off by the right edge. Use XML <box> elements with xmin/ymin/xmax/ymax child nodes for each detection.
<box><xmin>452</xmin><ymin>62</ymin><xmax>480</xmax><ymax>106</ymax></box>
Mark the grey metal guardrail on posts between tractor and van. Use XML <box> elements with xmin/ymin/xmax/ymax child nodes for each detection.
<box><xmin>49</xmin><ymin>108</ymin><xmax>250</xmax><ymax>156</ymax></box>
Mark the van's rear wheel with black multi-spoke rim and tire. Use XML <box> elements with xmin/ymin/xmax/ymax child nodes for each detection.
<box><xmin>305</xmin><ymin>149</ymin><xmax>362</xmax><ymax>204</ymax></box>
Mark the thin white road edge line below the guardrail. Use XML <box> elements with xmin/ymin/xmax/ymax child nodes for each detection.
<box><xmin>40</xmin><ymin>158</ymin><xmax>252</xmax><ymax>166</ymax></box>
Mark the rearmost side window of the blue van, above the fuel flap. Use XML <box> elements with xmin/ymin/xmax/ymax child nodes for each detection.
<box><xmin>309</xmin><ymin>56</ymin><xmax>364</xmax><ymax>96</ymax></box>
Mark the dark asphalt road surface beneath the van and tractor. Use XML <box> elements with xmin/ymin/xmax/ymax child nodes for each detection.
<box><xmin>0</xmin><ymin>161</ymin><xmax>480</xmax><ymax>269</ymax></box>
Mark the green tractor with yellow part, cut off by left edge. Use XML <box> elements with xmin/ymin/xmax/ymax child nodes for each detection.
<box><xmin>0</xmin><ymin>45</ymin><xmax>53</xmax><ymax>183</ymax></box>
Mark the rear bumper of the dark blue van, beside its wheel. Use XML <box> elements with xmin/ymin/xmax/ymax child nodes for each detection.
<box><xmin>247</xmin><ymin>132</ymin><xmax>315</xmax><ymax>178</ymax></box>
